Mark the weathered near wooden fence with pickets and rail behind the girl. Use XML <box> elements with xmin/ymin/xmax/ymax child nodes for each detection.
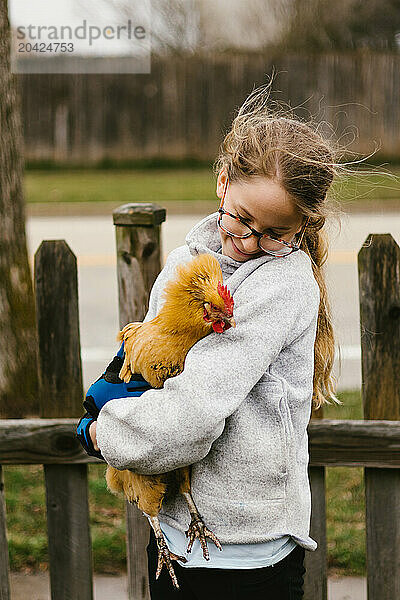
<box><xmin>0</xmin><ymin>204</ymin><xmax>400</xmax><ymax>600</ymax></box>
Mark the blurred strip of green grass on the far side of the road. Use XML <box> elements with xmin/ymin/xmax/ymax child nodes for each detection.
<box><xmin>24</xmin><ymin>167</ymin><xmax>400</xmax><ymax>207</ymax></box>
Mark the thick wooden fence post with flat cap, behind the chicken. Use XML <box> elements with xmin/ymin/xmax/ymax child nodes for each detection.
<box><xmin>113</xmin><ymin>203</ymin><xmax>166</xmax><ymax>600</ymax></box>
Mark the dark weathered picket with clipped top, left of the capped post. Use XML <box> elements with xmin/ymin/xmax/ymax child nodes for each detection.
<box><xmin>35</xmin><ymin>240</ymin><xmax>93</xmax><ymax>600</ymax></box>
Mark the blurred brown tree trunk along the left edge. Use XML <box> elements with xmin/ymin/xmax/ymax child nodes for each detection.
<box><xmin>0</xmin><ymin>0</ymin><xmax>39</xmax><ymax>418</ymax></box>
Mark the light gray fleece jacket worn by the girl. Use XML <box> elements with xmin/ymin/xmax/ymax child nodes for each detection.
<box><xmin>97</xmin><ymin>212</ymin><xmax>320</xmax><ymax>550</ymax></box>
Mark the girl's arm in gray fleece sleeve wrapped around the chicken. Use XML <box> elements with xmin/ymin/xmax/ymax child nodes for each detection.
<box><xmin>96</xmin><ymin>268</ymin><xmax>319</xmax><ymax>474</ymax></box>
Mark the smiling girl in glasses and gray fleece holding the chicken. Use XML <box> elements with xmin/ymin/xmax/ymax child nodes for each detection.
<box><xmin>90</xmin><ymin>86</ymin><xmax>340</xmax><ymax>600</ymax></box>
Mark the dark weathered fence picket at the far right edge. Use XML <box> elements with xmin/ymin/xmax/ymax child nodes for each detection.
<box><xmin>358</xmin><ymin>233</ymin><xmax>400</xmax><ymax>600</ymax></box>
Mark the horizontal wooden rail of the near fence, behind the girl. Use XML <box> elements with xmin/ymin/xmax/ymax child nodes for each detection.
<box><xmin>0</xmin><ymin>419</ymin><xmax>400</xmax><ymax>470</ymax></box>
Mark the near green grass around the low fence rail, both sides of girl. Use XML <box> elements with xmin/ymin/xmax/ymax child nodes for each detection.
<box><xmin>4</xmin><ymin>391</ymin><xmax>366</xmax><ymax>575</ymax></box>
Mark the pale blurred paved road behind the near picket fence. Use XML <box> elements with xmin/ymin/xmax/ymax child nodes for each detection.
<box><xmin>27</xmin><ymin>211</ymin><xmax>400</xmax><ymax>390</ymax></box>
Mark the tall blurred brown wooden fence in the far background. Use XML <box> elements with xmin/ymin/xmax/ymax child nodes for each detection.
<box><xmin>17</xmin><ymin>49</ymin><xmax>400</xmax><ymax>165</ymax></box>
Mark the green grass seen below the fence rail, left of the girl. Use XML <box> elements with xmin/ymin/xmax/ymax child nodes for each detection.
<box><xmin>3</xmin><ymin>465</ymin><xmax>126</xmax><ymax>574</ymax></box>
